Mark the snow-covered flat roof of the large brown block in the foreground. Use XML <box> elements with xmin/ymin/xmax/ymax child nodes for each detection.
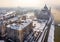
<box><xmin>7</xmin><ymin>20</ymin><xmax>32</xmax><ymax>30</ymax></box>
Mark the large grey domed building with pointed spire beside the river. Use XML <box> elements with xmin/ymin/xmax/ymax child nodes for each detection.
<box><xmin>37</xmin><ymin>5</ymin><xmax>51</xmax><ymax>20</ymax></box>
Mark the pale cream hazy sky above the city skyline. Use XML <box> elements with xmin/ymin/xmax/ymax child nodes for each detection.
<box><xmin>0</xmin><ymin>0</ymin><xmax>60</xmax><ymax>8</ymax></box>
